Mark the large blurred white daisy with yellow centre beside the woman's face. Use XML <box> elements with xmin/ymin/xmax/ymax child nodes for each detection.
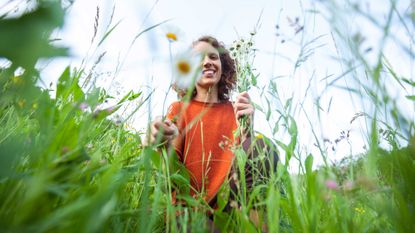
<box><xmin>173</xmin><ymin>50</ymin><xmax>202</xmax><ymax>90</ymax></box>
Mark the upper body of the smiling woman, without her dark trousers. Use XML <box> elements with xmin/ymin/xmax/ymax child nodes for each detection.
<box><xmin>151</xmin><ymin>36</ymin><xmax>254</xmax><ymax>203</ymax></box>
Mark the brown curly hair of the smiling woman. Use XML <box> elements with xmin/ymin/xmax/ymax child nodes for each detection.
<box><xmin>174</xmin><ymin>36</ymin><xmax>236</xmax><ymax>101</ymax></box>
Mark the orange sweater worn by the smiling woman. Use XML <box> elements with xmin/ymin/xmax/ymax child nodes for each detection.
<box><xmin>167</xmin><ymin>100</ymin><xmax>237</xmax><ymax>201</ymax></box>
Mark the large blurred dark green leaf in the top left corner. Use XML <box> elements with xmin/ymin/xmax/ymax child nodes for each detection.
<box><xmin>0</xmin><ymin>1</ymin><xmax>67</xmax><ymax>70</ymax></box>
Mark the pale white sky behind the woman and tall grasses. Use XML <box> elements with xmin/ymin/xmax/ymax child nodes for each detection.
<box><xmin>0</xmin><ymin>0</ymin><xmax>415</xmax><ymax>170</ymax></box>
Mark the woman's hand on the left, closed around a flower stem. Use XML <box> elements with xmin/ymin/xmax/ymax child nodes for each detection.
<box><xmin>150</xmin><ymin>117</ymin><xmax>179</xmax><ymax>144</ymax></box>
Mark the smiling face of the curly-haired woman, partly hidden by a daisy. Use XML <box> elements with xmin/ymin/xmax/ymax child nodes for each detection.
<box><xmin>193</xmin><ymin>41</ymin><xmax>222</xmax><ymax>88</ymax></box>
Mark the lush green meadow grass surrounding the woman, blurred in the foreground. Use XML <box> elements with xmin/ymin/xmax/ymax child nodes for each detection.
<box><xmin>0</xmin><ymin>1</ymin><xmax>415</xmax><ymax>232</ymax></box>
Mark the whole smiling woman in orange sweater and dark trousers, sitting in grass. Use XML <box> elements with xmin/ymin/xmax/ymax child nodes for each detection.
<box><xmin>146</xmin><ymin>36</ymin><xmax>278</xmax><ymax>231</ymax></box>
